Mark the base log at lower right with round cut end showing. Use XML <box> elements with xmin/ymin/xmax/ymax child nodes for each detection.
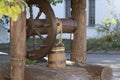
<box><xmin>77</xmin><ymin>64</ymin><xmax>113</xmax><ymax>80</ymax></box>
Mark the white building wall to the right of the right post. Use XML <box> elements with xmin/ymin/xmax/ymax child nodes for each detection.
<box><xmin>86</xmin><ymin>0</ymin><xmax>120</xmax><ymax>38</ymax></box>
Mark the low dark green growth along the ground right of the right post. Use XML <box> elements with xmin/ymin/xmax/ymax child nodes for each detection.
<box><xmin>87</xmin><ymin>36</ymin><xmax>120</xmax><ymax>50</ymax></box>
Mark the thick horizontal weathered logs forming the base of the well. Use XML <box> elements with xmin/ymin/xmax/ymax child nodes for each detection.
<box><xmin>0</xmin><ymin>63</ymin><xmax>113</xmax><ymax>80</ymax></box>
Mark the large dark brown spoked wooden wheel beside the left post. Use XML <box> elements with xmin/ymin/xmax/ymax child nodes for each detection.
<box><xmin>27</xmin><ymin>0</ymin><xmax>57</xmax><ymax>59</ymax></box>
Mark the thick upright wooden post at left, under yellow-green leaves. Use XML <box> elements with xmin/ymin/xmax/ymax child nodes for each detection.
<box><xmin>10</xmin><ymin>13</ymin><xmax>26</xmax><ymax>80</ymax></box>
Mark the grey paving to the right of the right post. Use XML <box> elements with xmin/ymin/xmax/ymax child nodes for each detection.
<box><xmin>87</xmin><ymin>54</ymin><xmax>120</xmax><ymax>80</ymax></box>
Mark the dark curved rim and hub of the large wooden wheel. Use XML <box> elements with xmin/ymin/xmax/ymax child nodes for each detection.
<box><xmin>27</xmin><ymin>0</ymin><xmax>57</xmax><ymax>59</ymax></box>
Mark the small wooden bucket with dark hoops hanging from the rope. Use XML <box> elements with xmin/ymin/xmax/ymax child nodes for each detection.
<box><xmin>48</xmin><ymin>46</ymin><xmax>66</xmax><ymax>69</ymax></box>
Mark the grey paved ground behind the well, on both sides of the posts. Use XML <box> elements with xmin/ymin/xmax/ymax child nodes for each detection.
<box><xmin>0</xmin><ymin>49</ymin><xmax>120</xmax><ymax>80</ymax></box>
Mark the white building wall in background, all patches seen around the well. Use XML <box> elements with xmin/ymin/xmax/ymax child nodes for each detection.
<box><xmin>0</xmin><ymin>0</ymin><xmax>120</xmax><ymax>42</ymax></box>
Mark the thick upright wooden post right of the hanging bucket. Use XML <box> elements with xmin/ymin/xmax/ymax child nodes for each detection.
<box><xmin>71</xmin><ymin>0</ymin><xmax>86</xmax><ymax>63</ymax></box>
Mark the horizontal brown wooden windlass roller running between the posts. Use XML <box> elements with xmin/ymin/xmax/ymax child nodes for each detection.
<box><xmin>27</xmin><ymin>19</ymin><xmax>77</xmax><ymax>34</ymax></box>
